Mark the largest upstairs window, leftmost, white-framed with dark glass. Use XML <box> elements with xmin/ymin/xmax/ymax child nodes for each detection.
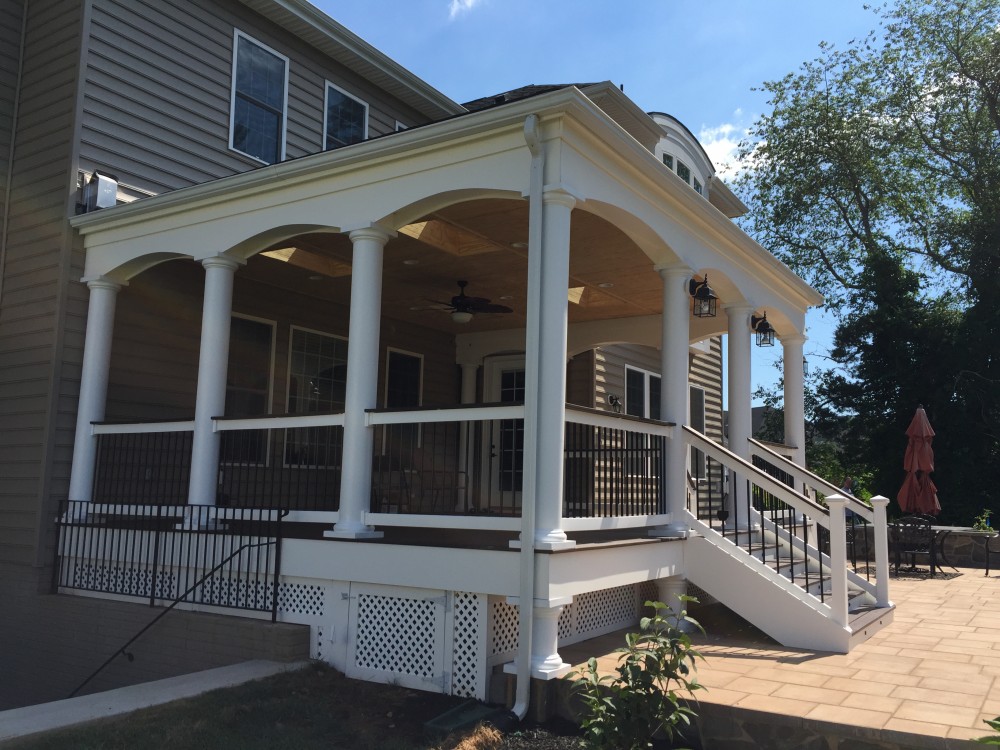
<box><xmin>229</xmin><ymin>31</ymin><xmax>288</xmax><ymax>164</ymax></box>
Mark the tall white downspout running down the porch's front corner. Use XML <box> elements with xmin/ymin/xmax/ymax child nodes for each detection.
<box><xmin>511</xmin><ymin>114</ymin><xmax>545</xmax><ymax>720</ymax></box>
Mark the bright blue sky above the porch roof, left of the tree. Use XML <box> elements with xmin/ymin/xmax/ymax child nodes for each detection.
<box><xmin>313</xmin><ymin>0</ymin><xmax>878</xmax><ymax>406</ymax></box>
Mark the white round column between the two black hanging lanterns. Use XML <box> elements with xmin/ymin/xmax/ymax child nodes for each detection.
<box><xmin>726</xmin><ymin>305</ymin><xmax>753</xmax><ymax>529</ymax></box>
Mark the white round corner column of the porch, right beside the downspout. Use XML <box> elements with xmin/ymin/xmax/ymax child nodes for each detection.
<box><xmin>522</xmin><ymin>190</ymin><xmax>576</xmax><ymax>549</ymax></box>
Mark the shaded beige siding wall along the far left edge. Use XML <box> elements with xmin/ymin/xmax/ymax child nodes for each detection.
<box><xmin>0</xmin><ymin>0</ymin><xmax>82</xmax><ymax>564</ymax></box>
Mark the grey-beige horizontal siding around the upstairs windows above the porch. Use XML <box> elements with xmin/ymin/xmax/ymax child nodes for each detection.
<box><xmin>80</xmin><ymin>0</ymin><xmax>432</xmax><ymax>193</ymax></box>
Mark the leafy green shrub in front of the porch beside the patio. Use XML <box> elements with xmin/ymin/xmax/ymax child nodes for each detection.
<box><xmin>570</xmin><ymin>596</ymin><xmax>704</xmax><ymax>750</ymax></box>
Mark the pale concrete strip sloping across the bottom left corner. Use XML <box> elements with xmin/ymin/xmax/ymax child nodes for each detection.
<box><xmin>0</xmin><ymin>660</ymin><xmax>309</xmax><ymax>742</ymax></box>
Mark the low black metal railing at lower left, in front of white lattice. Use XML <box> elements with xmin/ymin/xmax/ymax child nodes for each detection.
<box><xmin>53</xmin><ymin>502</ymin><xmax>287</xmax><ymax>619</ymax></box>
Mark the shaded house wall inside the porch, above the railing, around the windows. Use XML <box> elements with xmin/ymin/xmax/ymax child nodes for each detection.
<box><xmin>107</xmin><ymin>257</ymin><xmax>459</xmax><ymax>421</ymax></box>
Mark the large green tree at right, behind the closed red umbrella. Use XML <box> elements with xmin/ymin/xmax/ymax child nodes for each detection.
<box><xmin>739</xmin><ymin>0</ymin><xmax>1000</xmax><ymax>521</ymax></box>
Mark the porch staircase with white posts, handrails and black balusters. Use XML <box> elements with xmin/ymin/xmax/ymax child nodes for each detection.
<box><xmin>684</xmin><ymin>428</ymin><xmax>894</xmax><ymax>653</ymax></box>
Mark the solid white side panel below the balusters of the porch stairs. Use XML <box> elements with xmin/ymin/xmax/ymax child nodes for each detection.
<box><xmin>684</xmin><ymin>524</ymin><xmax>852</xmax><ymax>654</ymax></box>
